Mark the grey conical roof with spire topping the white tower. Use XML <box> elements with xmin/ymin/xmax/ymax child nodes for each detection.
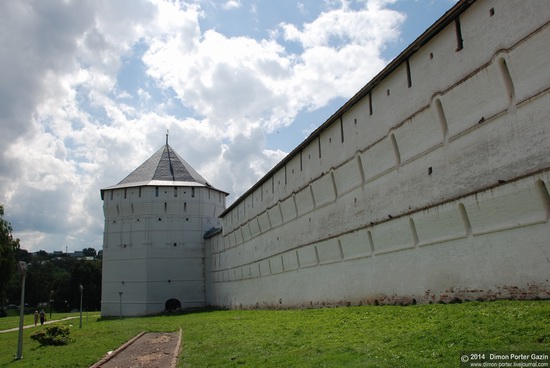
<box><xmin>101</xmin><ymin>144</ymin><xmax>227</xmax><ymax>195</ymax></box>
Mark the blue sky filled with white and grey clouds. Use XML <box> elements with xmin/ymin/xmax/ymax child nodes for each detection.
<box><xmin>0</xmin><ymin>0</ymin><xmax>455</xmax><ymax>252</ymax></box>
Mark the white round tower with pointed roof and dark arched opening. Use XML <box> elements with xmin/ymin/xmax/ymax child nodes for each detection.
<box><xmin>101</xmin><ymin>136</ymin><xmax>227</xmax><ymax>316</ymax></box>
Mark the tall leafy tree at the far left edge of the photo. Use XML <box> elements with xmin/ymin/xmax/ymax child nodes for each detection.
<box><xmin>0</xmin><ymin>205</ymin><xmax>19</xmax><ymax>314</ymax></box>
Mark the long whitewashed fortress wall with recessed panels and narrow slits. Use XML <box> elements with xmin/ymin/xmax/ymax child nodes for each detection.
<box><xmin>205</xmin><ymin>0</ymin><xmax>550</xmax><ymax>308</ymax></box>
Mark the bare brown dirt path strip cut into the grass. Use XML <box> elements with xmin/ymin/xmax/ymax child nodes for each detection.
<box><xmin>90</xmin><ymin>331</ymin><xmax>181</xmax><ymax>368</ymax></box>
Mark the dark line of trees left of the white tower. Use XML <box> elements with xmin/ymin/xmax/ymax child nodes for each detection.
<box><xmin>0</xmin><ymin>205</ymin><xmax>101</xmax><ymax>316</ymax></box>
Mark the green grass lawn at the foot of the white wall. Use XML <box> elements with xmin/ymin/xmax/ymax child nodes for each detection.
<box><xmin>0</xmin><ymin>301</ymin><xmax>550</xmax><ymax>368</ymax></box>
